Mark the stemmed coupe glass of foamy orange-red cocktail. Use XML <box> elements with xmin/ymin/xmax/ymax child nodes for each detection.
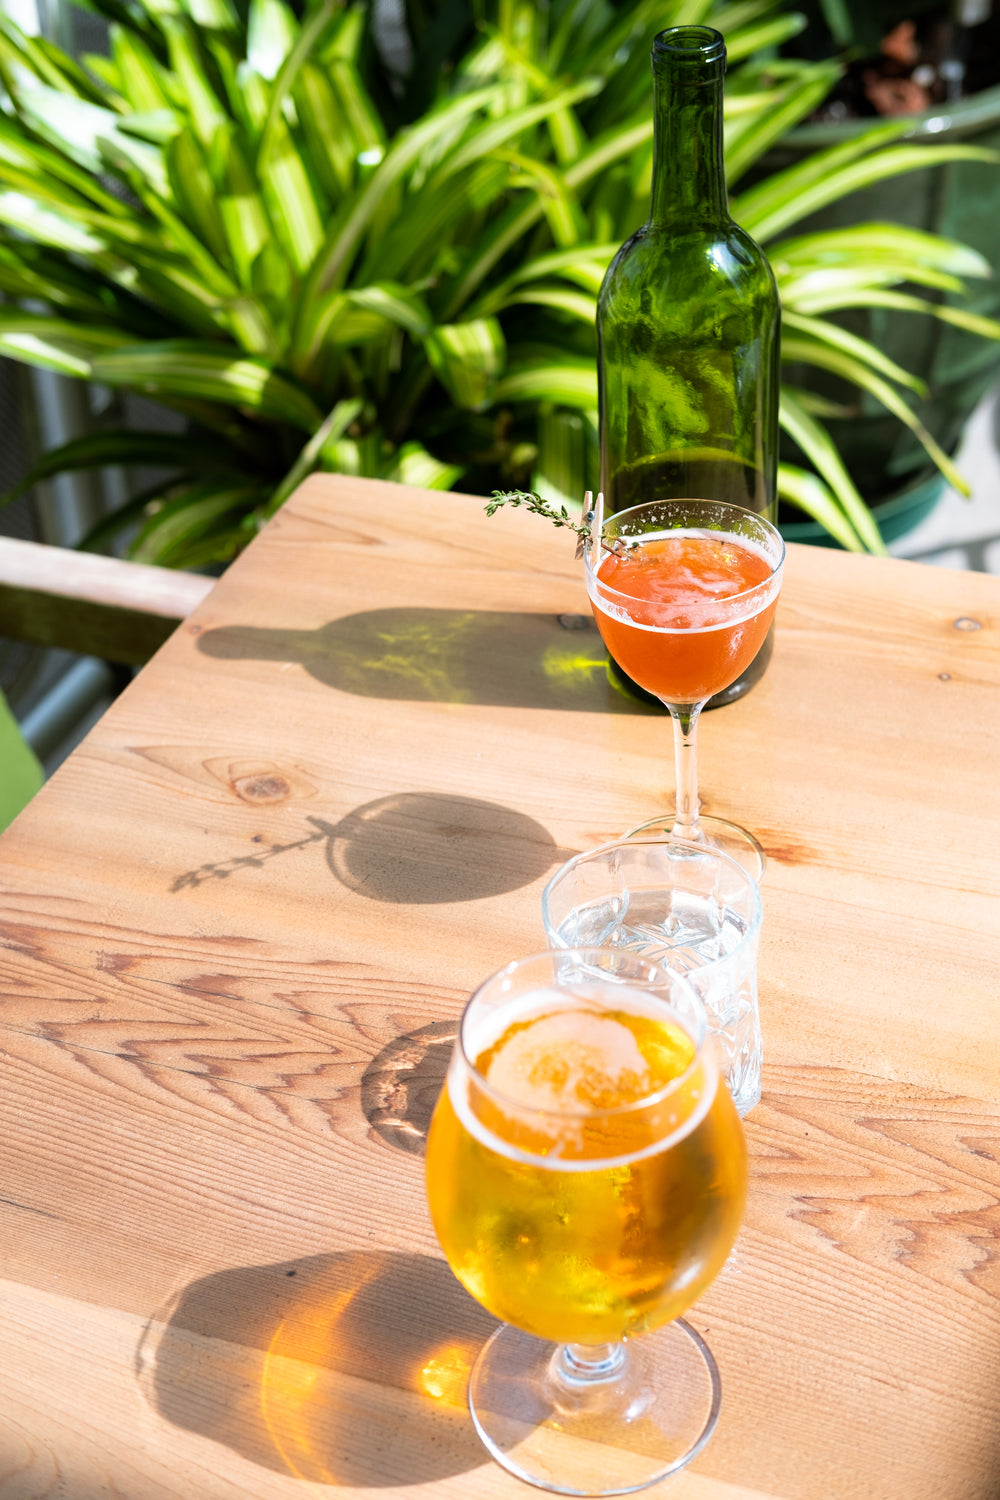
<box><xmin>586</xmin><ymin>500</ymin><xmax>784</xmax><ymax>879</ymax></box>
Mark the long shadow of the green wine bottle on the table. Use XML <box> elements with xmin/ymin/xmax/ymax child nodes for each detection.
<box><xmin>198</xmin><ymin>609</ymin><xmax>661</xmax><ymax>714</ymax></box>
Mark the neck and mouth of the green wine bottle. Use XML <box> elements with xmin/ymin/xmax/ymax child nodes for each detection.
<box><xmin>649</xmin><ymin>27</ymin><xmax>729</xmax><ymax>228</ymax></box>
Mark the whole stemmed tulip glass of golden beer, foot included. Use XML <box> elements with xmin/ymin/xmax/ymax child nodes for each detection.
<box><xmin>427</xmin><ymin>948</ymin><xmax>747</xmax><ymax>1496</ymax></box>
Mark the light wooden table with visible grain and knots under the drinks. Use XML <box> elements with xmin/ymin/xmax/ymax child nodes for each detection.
<box><xmin>0</xmin><ymin>479</ymin><xmax>1000</xmax><ymax>1500</ymax></box>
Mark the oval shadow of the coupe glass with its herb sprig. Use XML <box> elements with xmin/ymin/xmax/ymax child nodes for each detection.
<box><xmin>171</xmin><ymin>792</ymin><xmax>574</xmax><ymax>906</ymax></box>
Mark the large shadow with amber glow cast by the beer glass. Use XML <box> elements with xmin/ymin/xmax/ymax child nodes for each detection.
<box><xmin>136</xmin><ymin>1253</ymin><xmax>496</xmax><ymax>1488</ymax></box>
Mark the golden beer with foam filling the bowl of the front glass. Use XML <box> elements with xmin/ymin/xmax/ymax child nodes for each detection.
<box><xmin>427</xmin><ymin>984</ymin><xmax>747</xmax><ymax>1344</ymax></box>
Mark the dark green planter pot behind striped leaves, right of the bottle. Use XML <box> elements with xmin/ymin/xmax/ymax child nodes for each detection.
<box><xmin>766</xmin><ymin>87</ymin><xmax>1000</xmax><ymax>507</ymax></box>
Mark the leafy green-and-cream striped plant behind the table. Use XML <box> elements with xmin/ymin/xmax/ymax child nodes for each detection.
<box><xmin>0</xmin><ymin>0</ymin><xmax>1000</xmax><ymax>567</ymax></box>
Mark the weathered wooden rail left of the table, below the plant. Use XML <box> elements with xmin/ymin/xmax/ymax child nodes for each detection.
<box><xmin>0</xmin><ymin>537</ymin><xmax>214</xmax><ymax>665</ymax></box>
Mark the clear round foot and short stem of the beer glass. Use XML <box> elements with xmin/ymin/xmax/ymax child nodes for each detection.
<box><xmin>469</xmin><ymin>1319</ymin><xmax>721</xmax><ymax>1496</ymax></box>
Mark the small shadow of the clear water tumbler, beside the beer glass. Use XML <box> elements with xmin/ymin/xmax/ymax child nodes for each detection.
<box><xmin>361</xmin><ymin>1019</ymin><xmax>459</xmax><ymax>1157</ymax></box>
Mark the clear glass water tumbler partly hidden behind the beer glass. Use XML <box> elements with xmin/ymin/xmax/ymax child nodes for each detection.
<box><xmin>541</xmin><ymin>837</ymin><xmax>763</xmax><ymax>1116</ymax></box>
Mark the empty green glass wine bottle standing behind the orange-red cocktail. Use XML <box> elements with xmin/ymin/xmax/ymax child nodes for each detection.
<box><xmin>597</xmin><ymin>26</ymin><xmax>780</xmax><ymax>707</ymax></box>
